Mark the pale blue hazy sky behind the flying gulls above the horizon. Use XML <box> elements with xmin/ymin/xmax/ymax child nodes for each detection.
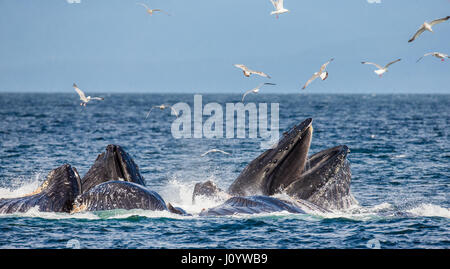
<box><xmin>0</xmin><ymin>0</ymin><xmax>450</xmax><ymax>94</ymax></box>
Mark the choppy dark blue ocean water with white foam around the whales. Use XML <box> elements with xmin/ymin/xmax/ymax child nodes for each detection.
<box><xmin>0</xmin><ymin>93</ymin><xmax>450</xmax><ymax>249</ymax></box>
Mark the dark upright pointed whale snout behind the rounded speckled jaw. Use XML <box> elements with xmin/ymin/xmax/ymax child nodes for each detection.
<box><xmin>81</xmin><ymin>145</ymin><xmax>145</xmax><ymax>193</ymax></box>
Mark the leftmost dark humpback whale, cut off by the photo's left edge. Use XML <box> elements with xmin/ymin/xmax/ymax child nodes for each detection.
<box><xmin>0</xmin><ymin>164</ymin><xmax>81</xmax><ymax>214</ymax></box>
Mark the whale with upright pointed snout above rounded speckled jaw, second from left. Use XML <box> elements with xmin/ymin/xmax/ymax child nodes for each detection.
<box><xmin>71</xmin><ymin>145</ymin><xmax>187</xmax><ymax>215</ymax></box>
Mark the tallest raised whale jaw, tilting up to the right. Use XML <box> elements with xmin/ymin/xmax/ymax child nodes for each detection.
<box><xmin>228</xmin><ymin>118</ymin><xmax>313</xmax><ymax>196</ymax></box>
